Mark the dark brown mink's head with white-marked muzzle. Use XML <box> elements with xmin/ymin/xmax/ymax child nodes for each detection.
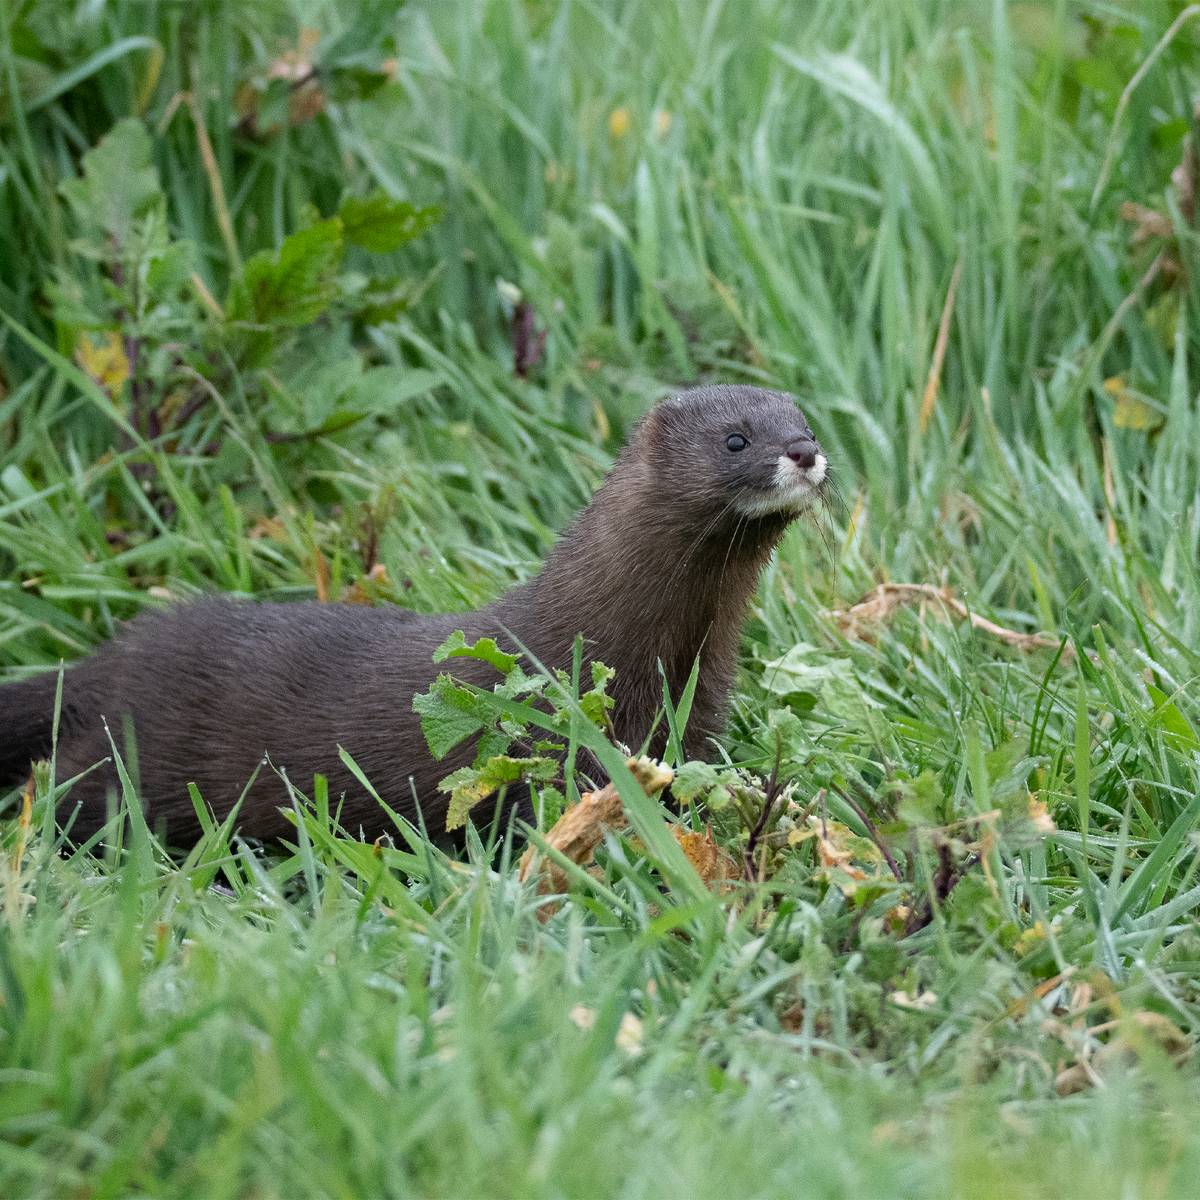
<box><xmin>642</xmin><ymin>386</ymin><xmax>827</xmax><ymax>521</ymax></box>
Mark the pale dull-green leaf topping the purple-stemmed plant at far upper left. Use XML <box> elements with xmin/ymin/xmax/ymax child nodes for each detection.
<box><xmin>60</xmin><ymin>116</ymin><xmax>162</xmax><ymax>252</ymax></box>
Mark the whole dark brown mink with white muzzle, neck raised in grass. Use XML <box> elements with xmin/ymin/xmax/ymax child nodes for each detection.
<box><xmin>0</xmin><ymin>386</ymin><xmax>826</xmax><ymax>846</ymax></box>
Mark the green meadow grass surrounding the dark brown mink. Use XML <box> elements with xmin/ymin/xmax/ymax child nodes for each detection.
<box><xmin>0</xmin><ymin>0</ymin><xmax>1200</xmax><ymax>1198</ymax></box>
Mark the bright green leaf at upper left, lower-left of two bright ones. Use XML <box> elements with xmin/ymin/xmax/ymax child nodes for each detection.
<box><xmin>227</xmin><ymin>217</ymin><xmax>344</xmax><ymax>328</ymax></box>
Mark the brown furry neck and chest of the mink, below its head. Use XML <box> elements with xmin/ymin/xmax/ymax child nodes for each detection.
<box><xmin>493</xmin><ymin>461</ymin><xmax>787</xmax><ymax>715</ymax></box>
